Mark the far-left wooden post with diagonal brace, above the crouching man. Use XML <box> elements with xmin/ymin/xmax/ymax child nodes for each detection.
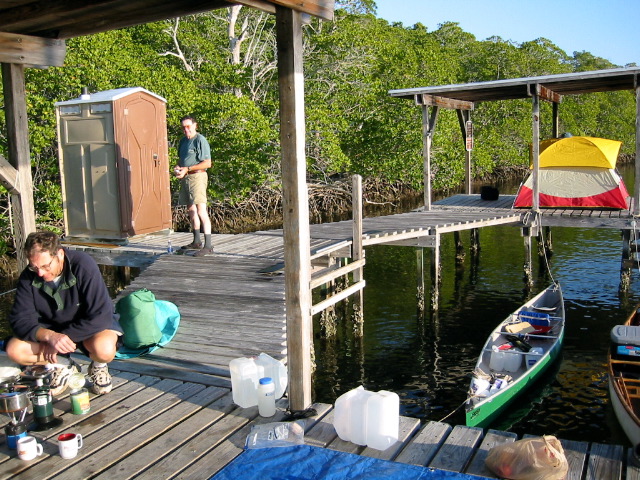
<box><xmin>2</xmin><ymin>63</ymin><xmax>36</xmax><ymax>271</ymax></box>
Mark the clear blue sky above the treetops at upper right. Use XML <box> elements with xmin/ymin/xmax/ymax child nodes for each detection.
<box><xmin>375</xmin><ymin>0</ymin><xmax>640</xmax><ymax>67</ymax></box>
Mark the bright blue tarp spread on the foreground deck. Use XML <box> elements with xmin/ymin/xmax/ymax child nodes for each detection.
<box><xmin>211</xmin><ymin>445</ymin><xmax>483</xmax><ymax>480</ymax></box>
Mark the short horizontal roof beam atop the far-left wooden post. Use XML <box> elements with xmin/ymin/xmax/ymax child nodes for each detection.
<box><xmin>0</xmin><ymin>32</ymin><xmax>67</xmax><ymax>67</ymax></box>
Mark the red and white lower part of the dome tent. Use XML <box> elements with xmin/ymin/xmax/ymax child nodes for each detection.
<box><xmin>513</xmin><ymin>167</ymin><xmax>629</xmax><ymax>209</ymax></box>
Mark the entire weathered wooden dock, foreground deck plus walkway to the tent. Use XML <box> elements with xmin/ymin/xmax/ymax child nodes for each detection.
<box><xmin>0</xmin><ymin>195</ymin><xmax>640</xmax><ymax>480</ymax></box>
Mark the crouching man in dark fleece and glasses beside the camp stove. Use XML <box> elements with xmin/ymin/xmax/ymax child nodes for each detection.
<box><xmin>6</xmin><ymin>232</ymin><xmax>122</xmax><ymax>395</ymax></box>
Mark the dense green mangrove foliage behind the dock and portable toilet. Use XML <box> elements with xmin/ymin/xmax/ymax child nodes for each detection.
<box><xmin>0</xmin><ymin>6</ymin><xmax>636</xmax><ymax>253</ymax></box>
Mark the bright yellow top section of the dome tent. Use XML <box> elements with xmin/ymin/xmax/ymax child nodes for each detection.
<box><xmin>540</xmin><ymin>137</ymin><xmax>622</xmax><ymax>168</ymax></box>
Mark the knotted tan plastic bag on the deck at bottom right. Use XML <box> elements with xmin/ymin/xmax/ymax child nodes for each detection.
<box><xmin>485</xmin><ymin>435</ymin><xmax>569</xmax><ymax>480</ymax></box>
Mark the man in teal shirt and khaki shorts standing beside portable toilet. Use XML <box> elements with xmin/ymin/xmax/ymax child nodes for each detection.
<box><xmin>174</xmin><ymin>116</ymin><xmax>213</xmax><ymax>257</ymax></box>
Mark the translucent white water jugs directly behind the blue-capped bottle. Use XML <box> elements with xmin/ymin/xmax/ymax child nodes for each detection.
<box><xmin>229</xmin><ymin>353</ymin><xmax>288</xmax><ymax>408</ymax></box>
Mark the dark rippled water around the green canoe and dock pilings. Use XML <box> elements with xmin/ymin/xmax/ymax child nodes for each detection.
<box><xmin>0</xmin><ymin>166</ymin><xmax>640</xmax><ymax>445</ymax></box>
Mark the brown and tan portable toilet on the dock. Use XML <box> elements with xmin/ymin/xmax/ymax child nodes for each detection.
<box><xmin>55</xmin><ymin>87</ymin><xmax>172</xmax><ymax>243</ymax></box>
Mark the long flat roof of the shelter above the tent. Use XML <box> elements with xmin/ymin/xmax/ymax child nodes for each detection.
<box><xmin>389</xmin><ymin>67</ymin><xmax>640</xmax><ymax>102</ymax></box>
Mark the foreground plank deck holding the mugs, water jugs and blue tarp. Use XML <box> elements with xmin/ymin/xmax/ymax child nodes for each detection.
<box><xmin>0</xmin><ymin>368</ymin><xmax>640</xmax><ymax>480</ymax></box>
